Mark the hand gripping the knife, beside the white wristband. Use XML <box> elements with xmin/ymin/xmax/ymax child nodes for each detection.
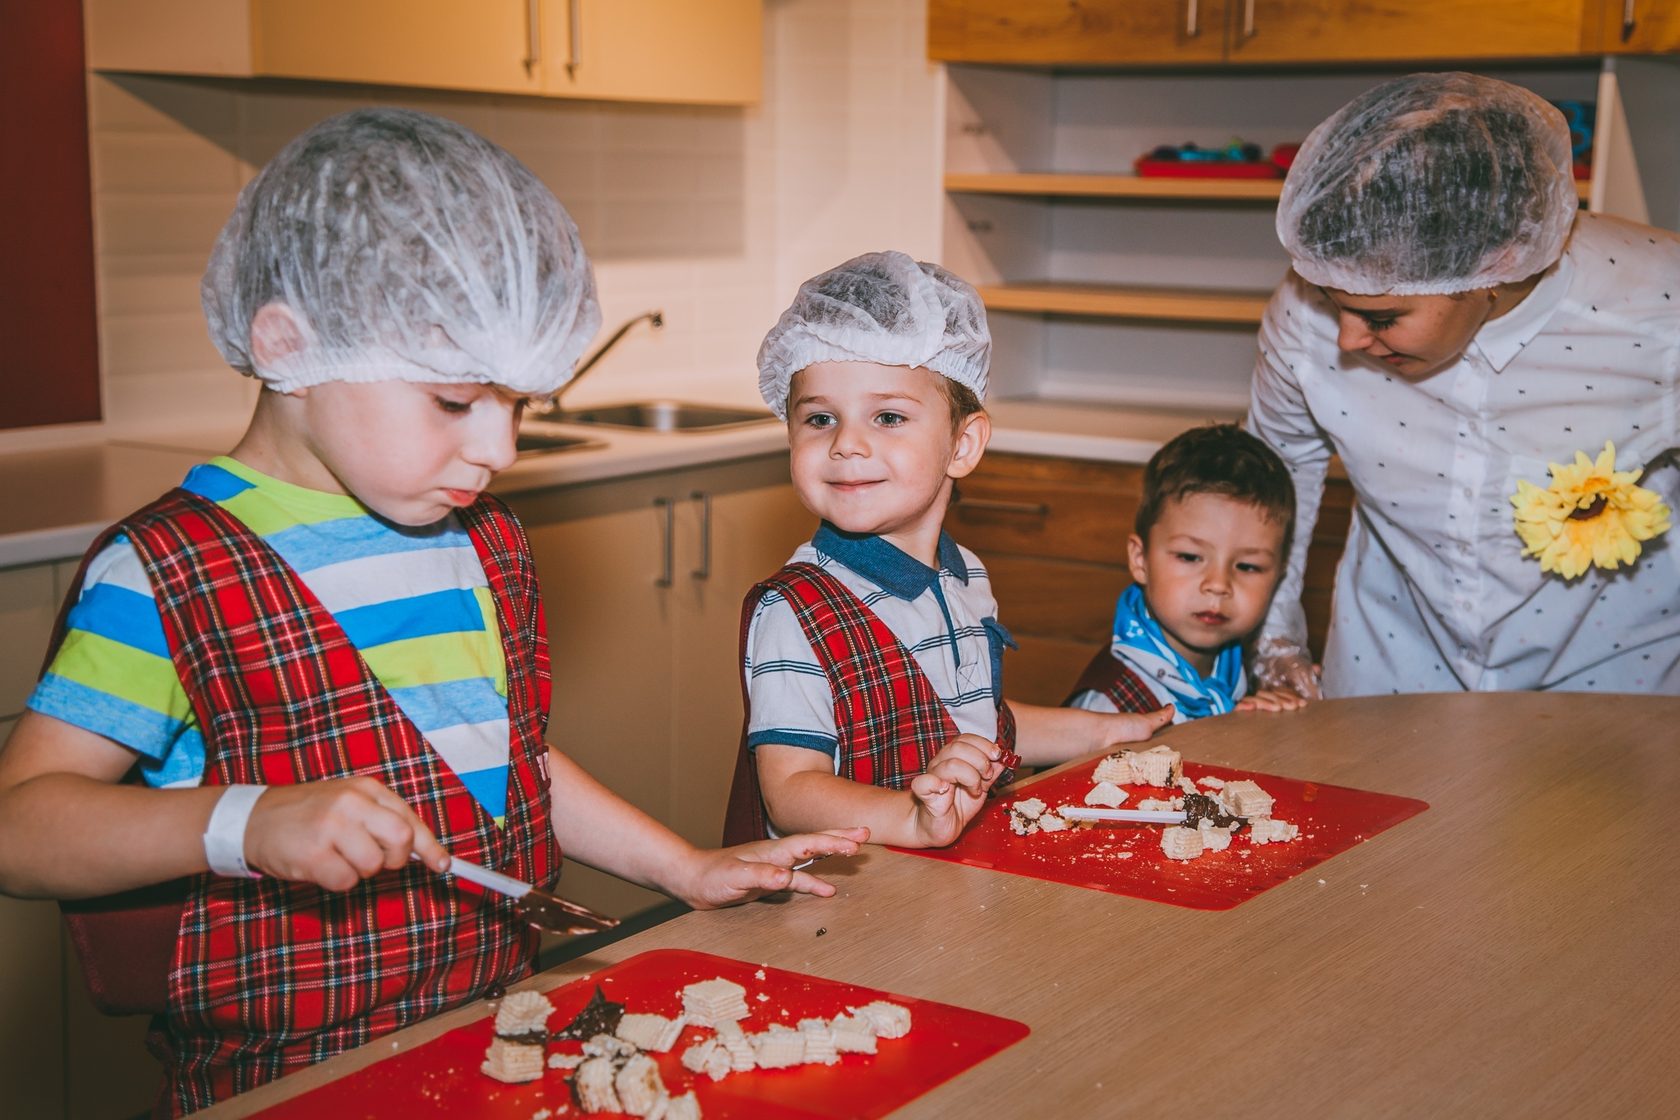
<box><xmin>245</xmin><ymin>777</ymin><xmax>449</xmax><ymax>890</ymax></box>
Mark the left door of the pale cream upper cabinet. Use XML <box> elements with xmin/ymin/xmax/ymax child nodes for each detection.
<box><xmin>250</xmin><ymin>0</ymin><xmax>543</xmax><ymax>94</ymax></box>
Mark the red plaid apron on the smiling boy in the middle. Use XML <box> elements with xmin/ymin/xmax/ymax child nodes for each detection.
<box><xmin>724</xmin><ymin>563</ymin><xmax>1018</xmax><ymax>845</ymax></box>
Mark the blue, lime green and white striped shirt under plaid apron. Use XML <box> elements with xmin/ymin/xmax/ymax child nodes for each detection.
<box><xmin>29</xmin><ymin>457</ymin><xmax>507</xmax><ymax>824</ymax></box>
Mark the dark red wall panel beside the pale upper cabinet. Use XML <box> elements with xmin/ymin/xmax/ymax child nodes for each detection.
<box><xmin>0</xmin><ymin>0</ymin><xmax>99</xmax><ymax>428</ymax></box>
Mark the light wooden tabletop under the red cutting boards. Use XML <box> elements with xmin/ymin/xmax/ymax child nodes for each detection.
<box><xmin>202</xmin><ymin>693</ymin><xmax>1680</xmax><ymax>1118</ymax></box>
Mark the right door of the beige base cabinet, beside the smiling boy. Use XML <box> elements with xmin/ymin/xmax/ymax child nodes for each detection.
<box><xmin>667</xmin><ymin>455</ymin><xmax>816</xmax><ymax>846</ymax></box>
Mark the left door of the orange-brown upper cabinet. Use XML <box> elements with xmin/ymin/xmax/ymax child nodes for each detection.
<box><xmin>927</xmin><ymin>0</ymin><xmax>1240</xmax><ymax>65</ymax></box>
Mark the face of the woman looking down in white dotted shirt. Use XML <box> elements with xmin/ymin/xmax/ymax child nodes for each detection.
<box><xmin>1324</xmin><ymin>287</ymin><xmax>1497</xmax><ymax>379</ymax></box>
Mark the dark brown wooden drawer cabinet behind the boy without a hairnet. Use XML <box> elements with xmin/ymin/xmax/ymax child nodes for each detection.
<box><xmin>946</xmin><ymin>453</ymin><xmax>1352</xmax><ymax>704</ymax></box>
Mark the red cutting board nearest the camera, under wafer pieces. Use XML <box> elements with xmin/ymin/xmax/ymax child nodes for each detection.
<box><xmin>257</xmin><ymin>949</ymin><xmax>1028</xmax><ymax>1120</ymax></box>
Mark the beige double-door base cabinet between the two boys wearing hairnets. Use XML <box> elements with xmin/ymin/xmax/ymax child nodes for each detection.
<box><xmin>507</xmin><ymin>453</ymin><xmax>816</xmax><ymax>917</ymax></box>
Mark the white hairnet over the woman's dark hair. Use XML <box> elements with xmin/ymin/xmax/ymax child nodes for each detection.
<box><xmin>1277</xmin><ymin>74</ymin><xmax>1578</xmax><ymax>296</ymax></box>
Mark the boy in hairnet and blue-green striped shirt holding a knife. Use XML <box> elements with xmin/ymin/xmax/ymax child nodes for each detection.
<box><xmin>0</xmin><ymin>109</ymin><xmax>865</xmax><ymax>1113</ymax></box>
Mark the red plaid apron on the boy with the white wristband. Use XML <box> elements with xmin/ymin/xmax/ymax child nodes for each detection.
<box><xmin>54</xmin><ymin>490</ymin><xmax>559</xmax><ymax>1115</ymax></box>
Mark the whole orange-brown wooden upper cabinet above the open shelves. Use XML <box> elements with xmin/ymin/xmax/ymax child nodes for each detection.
<box><xmin>927</xmin><ymin>0</ymin><xmax>1680</xmax><ymax>67</ymax></box>
